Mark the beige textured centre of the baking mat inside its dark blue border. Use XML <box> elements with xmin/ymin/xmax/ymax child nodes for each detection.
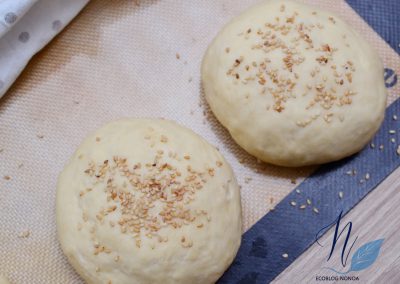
<box><xmin>0</xmin><ymin>0</ymin><xmax>400</xmax><ymax>283</ymax></box>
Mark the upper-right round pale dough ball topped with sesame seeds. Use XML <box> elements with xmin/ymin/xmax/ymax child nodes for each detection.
<box><xmin>202</xmin><ymin>0</ymin><xmax>387</xmax><ymax>166</ymax></box>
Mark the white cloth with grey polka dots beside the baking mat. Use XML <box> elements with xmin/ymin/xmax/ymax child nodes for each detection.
<box><xmin>0</xmin><ymin>0</ymin><xmax>89</xmax><ymax>98</ymax></box>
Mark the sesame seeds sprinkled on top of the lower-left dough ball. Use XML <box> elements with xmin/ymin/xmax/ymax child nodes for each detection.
<box><xmin>78</xmin><ymin>135</ymin><xmax>223</xmax><ymax>255</ymax></box>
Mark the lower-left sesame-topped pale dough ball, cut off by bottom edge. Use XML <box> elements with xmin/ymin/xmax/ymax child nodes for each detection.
<box><xmin>57</xmin><ymin>119</ymin><xmax>242</xmax><ymax>284</ymax></box>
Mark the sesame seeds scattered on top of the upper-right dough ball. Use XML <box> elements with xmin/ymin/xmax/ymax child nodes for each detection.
<box><xmin>225</xmin><ymin>5</ymin><xmax>356</xmax><ymax>127</ymax></box>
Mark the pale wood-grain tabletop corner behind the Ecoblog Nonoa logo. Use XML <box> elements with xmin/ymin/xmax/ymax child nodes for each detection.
<box><xmin>272</xmin><ymin>165</ymin><xmax>400</xmax><ymax>284</ymax></box>
